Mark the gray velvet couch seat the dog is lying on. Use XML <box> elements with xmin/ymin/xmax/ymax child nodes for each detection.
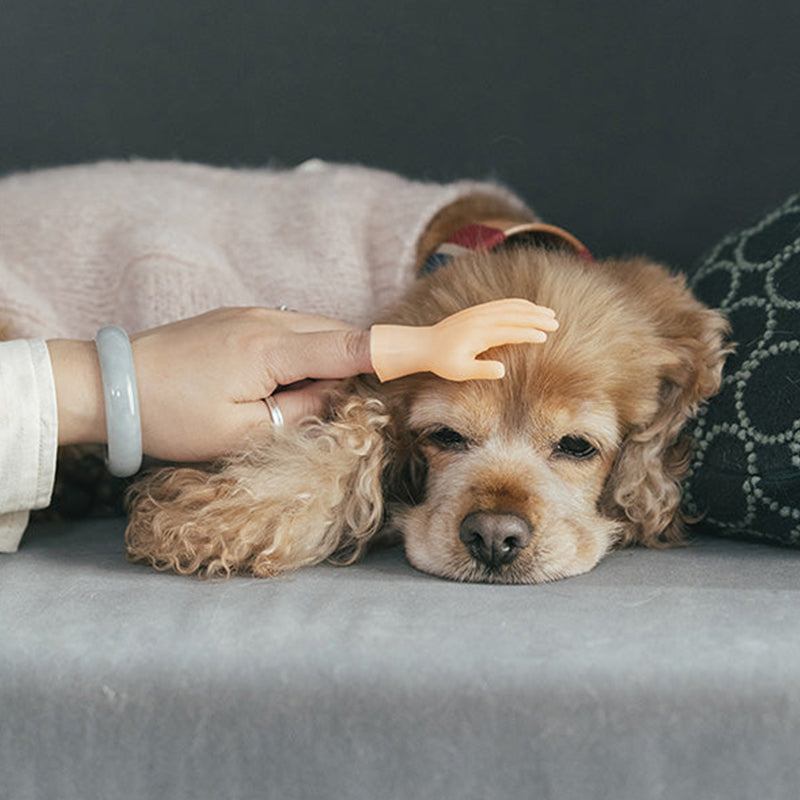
<box><xmin>0</xmin><ymin>520</ymin><xmax>800</xmax><ymax>800</ymax></box>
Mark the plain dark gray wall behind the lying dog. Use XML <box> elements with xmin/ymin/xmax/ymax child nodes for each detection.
<box><xmin>0</xmin><ymin>0</ymin><xmax>800</xmax><ymax>266</ymax></box>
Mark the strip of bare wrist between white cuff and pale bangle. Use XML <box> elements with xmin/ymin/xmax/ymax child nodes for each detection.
<box><xmin>47</xmin><ymin>339</ymin><xmax>106</xmax><ymax>445</ymax></box>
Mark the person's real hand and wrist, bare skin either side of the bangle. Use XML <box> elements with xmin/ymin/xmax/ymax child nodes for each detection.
<box><xmin>48</xmin><ymin>308</ymin><xmax>371</xmax><ymax>461</ymax></box>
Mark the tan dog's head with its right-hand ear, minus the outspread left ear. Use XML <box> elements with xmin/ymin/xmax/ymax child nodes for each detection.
<box><xmin>372</xmin><ymin>248</ymin><xmax>727</xmax><ymax>583</ymax></box>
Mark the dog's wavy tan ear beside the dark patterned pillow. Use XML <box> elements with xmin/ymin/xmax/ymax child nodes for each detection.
<box><xmin>601</xmin><ymin>265</ymin><xmax>733</xmax><ymax>547</ymax></box>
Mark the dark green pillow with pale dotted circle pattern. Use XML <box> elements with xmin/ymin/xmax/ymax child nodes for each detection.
<box><xmin>686</xmin><ymin>195</ymin><xmax>800</xmax><ymax>545</ymax></box>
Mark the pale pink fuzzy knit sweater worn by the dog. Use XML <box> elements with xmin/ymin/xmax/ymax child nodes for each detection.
<box><xmin>0</xmin><ymin>161</ymin><xmax>533</xmax><ymax>338</ymax></box>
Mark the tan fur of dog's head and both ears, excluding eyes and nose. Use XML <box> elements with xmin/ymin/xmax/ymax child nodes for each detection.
<box><xmin>127</xmin><ymin>244</ymin><xmax>727</xmax><ymax>583</ymax></box>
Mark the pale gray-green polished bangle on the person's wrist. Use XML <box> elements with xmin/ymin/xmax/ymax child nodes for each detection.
<box><xmin>95</xmin><ymin>325</ymin><xmax>142</xmax><ymax>478</ymax></box>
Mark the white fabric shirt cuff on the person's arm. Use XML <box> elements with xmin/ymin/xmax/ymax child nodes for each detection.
<box><xmin>0</xmin><ymin>339</ymin><xmax>58</xmax><ymax>553</ymax></box>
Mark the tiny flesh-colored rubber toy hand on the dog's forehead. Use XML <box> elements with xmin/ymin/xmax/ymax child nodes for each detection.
<box><xmin>371</xmin><ymin>298</ymin><xmax>558</xmax><ymax>382</ymax></box>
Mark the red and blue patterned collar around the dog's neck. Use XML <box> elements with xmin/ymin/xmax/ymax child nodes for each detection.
<box><xmin>419</xmin><ymin>220</ymin><xmax>594</xmax><ymax>277</ymax></box>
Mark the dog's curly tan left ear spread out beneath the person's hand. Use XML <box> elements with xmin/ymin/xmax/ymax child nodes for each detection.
<box><xmin>126</xmin><ymin>397</ymin><xmax>389</xmax><ymax>577</ymax></box>
